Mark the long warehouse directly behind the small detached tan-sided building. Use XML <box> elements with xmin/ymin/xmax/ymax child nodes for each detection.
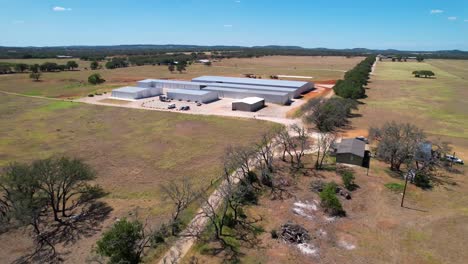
<box><xmin>203</xmin><ymin>86</ymin><xmax>290</xmax><ymax>104</ymax></box>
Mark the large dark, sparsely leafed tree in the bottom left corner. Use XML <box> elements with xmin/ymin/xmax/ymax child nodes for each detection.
<box><xmin>0</xmin><ymin>157</ymin><xmax>111</xmax><ymax>263</ymax></box>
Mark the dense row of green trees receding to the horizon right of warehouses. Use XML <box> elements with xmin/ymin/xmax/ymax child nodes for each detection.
<box><xmin>333</xmin><ymin>56</ymin><xmax>376</xmax><ymax>99</ymax></box>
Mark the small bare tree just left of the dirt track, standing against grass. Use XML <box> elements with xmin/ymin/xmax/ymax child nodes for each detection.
<box><xmin>161</xmin><ymin>177</ymin><xmax>197</xmax><ymax>236</ymax></box>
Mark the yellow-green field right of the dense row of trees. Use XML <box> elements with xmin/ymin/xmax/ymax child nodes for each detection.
<box><xmin>353</xmin><ymin>60</ymin><xmax>468</xmax><ymax>147</ymax></box>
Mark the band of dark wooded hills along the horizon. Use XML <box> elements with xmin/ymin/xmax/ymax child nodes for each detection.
<box><xmin>0</xmin><ymin>44</ymin><xmax>468</xmax><ymax>59</ymax></box>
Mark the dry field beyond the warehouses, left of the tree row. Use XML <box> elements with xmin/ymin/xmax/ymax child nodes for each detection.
<box><xmin>0</xmin><ymin>56</ymin><xmax>362</xmax><ymax>98</ymax></box>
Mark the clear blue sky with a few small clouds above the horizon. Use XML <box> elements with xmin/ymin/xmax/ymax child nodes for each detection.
<box><xmin>0</xmin><ymin>0</ymin><xmax>468</xmax><ymax>50</ymax></box>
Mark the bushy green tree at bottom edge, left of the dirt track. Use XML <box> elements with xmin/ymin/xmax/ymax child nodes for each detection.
<box><xmin>97</xmin><ymin>218</ymin><xmax>150</xmax><ymax>264</ymax></box>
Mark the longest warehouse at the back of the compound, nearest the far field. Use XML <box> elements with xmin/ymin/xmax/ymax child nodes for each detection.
<box><xmin>192</xmin><ymin>76</ymin><xmax>314</xmax><ymax>95</ymax></box>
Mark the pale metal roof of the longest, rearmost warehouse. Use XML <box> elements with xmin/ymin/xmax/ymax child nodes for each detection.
<box><xmin>192</xmin><ymin>76</ymin><xmax>307</xmax><ymax>88</ymax></box>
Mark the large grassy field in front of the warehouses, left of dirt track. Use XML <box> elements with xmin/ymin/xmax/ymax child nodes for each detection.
<box><xmin>0</xmin><ymin>94</ymin><xmax>274</xmax><ymax>263</ymax></box>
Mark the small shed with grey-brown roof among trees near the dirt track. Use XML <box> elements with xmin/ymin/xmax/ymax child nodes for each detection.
<box><xmin>336</xmin><ymin>138</ymin><xmax>366</xmax><ymax>166</ymax></box>
